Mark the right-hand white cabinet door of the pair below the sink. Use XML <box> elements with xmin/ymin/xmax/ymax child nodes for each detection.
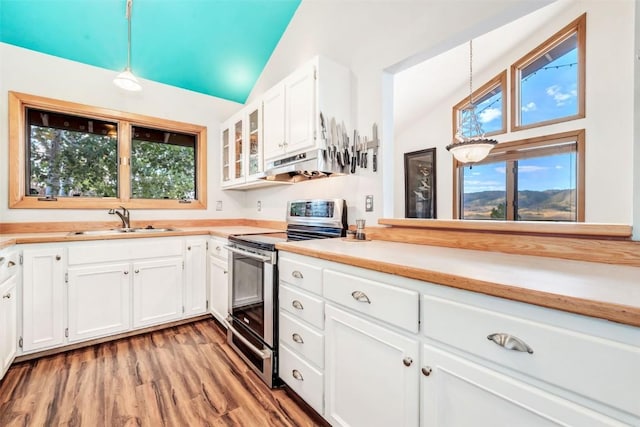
<box><xmin>133</xmin><ymin>258</ymin><xmax>183</xmax><ymax>328</ymax></box>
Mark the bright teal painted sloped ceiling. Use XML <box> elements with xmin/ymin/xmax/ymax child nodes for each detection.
<box><xmin>0</xmin><ymin>0</ymin><xmax>301</xmax><ymax>103</ymax></box>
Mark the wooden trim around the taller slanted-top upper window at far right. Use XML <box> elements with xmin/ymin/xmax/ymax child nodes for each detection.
<box><xmin>510</xmin><ymin>13</ymin><xmax>587</xmax><ymax>131</ymax></box>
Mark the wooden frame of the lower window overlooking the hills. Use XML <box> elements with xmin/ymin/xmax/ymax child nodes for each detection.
<box><xmin>453</xmin><ymin>129</ymin><xmax>585</xmax><ymax>223</ymax></box>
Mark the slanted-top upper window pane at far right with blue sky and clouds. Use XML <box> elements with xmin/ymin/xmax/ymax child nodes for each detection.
<box><xmin>520</xmin><ymin>33</ymin><xmax>578</xmax><ymax>125</ymax></box>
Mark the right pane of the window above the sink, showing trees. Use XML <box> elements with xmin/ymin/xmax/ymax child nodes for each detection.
<box><xmin>131</xmin><ymin>127</ymin><xmax>196</xmax><ymax>200</ymax></box>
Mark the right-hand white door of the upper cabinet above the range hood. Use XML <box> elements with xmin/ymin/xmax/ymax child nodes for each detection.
<box><xmin>285</xmin><ymin>65</ymin><xmax>316</xmax><ymax>153</ymax></box>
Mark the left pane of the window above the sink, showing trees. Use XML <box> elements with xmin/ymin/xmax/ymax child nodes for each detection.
<box><xmin>26</xmin><ymin>109</ymin><xmax>118</xmax><ymax>197</ymax></box>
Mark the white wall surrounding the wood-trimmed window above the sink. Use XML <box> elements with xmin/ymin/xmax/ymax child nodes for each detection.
<box><xmin>0</xmin><ymin>43</ymin><xmax>245</xmax><ymax>222</ymax></box>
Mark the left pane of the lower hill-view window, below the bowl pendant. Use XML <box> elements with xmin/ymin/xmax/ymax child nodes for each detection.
<box><xmin>461</xmin><ymin>162</ymin><xmax>507</xmax><ymax>220</ymax></box>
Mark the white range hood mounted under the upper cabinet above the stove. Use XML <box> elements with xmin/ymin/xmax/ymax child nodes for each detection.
<box><xmin>260</xmin><ymin>149</ymin><xmax>344</xmax><ymax>182</ymax></box>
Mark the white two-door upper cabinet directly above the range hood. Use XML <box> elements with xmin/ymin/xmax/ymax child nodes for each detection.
<box><xmin>262</xmin><ymin>56</ymin><xmax>351</xmax><ymax>165</ymax></box>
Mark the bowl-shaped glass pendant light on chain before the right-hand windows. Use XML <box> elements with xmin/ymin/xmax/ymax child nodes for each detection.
<box><xmin>446</xmin><ymin>40</ymin><xmax>498</xmax><ymax>163</ymax></box>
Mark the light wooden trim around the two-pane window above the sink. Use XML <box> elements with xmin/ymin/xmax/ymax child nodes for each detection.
<box><xmin>9</xmin><ymin>91</ymin><xmax>207</xmax><ymax>209</ymax></box>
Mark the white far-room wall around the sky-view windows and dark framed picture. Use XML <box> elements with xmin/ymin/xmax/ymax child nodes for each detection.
<box><xmin>394</xmin><ymin>0</ymin><xmax>639</xmax><ymax>224</ymax></box>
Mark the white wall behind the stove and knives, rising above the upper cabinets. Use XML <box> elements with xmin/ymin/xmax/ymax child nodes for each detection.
<box><xmin>246</xmin><ymin>0</ymin><xmax>551</xmax><ymax>224</ymax></box>
